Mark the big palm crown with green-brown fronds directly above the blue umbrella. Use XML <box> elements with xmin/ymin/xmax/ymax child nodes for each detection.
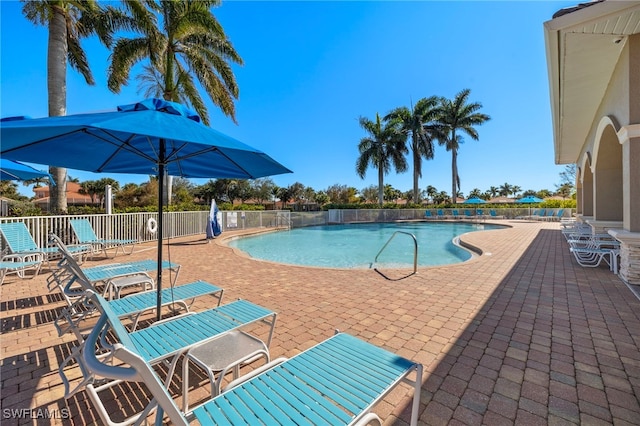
<box><xmin>108</xmin><ymin>0</ymin><xmax>243</xmax><ymax>125</ymax></box>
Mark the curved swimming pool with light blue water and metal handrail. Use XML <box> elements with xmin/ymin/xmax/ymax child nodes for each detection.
<box><xmin>229</xmin><ymin>222</ymin><xmax>504</xmax><ymax>268</ymax></box>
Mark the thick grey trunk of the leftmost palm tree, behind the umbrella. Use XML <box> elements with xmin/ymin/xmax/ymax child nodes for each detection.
<box><xmin>47</xmin><ymin>5</ymin><xmax>68</xmax><ymax>213</ymax></box>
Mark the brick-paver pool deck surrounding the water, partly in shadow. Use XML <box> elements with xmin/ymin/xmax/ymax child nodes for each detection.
<box><xmin>0</xmin><ymin>221</ymin><xmax>640</xmax><ymax>425</ymax></box>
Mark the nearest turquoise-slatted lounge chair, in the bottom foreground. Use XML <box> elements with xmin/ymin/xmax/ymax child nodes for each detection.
<box><xmin>82</xmin><ymin>302</ymin><xmax>422</xmax><ymax>426</ymax></box>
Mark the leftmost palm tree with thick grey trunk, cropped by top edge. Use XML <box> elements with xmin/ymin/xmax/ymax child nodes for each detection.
<box><xmin>22</xmin><ymin>0</ymin><xmax>122</xmax><ymax>213</ymax></box>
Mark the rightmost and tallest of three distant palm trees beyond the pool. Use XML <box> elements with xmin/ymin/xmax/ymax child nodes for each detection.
<box><xmin>438</xmin><ymin>89</ymin><xmax>491</xmax><ymax>204</ymax></box>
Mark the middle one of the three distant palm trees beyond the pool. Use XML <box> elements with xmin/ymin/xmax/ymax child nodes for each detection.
<box><xmin>384</xmin><ymin>96</ymin><xmax>439</xmax><ymax>203</ymax></box>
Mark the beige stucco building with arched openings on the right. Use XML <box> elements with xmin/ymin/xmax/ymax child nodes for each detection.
<box><xmin>544</xmin><ymin>0</ymin><xmax>640</xmax><ymax>284</ymax></box>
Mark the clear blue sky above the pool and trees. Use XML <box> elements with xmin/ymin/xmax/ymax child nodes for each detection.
<box><xmin>0</xmin><ymin>1</ymin><xmax>576</xmax><ymax>196</ymax></box>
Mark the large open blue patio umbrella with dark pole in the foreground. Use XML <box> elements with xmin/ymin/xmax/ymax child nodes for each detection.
<box><xmin>0</xmin><ymin>99</ymin><xmax>291</xmax><ymax>318</ymax></box>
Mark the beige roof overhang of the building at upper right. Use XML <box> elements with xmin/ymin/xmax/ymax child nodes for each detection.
<box><xmin>544</xmin><ymin>0</ymin><xmax>640</xmax><ymax>164</ymax></box>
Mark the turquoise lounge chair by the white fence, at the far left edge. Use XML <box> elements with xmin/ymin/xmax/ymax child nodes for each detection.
<box><xmin>0</xmin><ymin>222</ymin><xmax>91</xmax><ymax>263</ymax></box>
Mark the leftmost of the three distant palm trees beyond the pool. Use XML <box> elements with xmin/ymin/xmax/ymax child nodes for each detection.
<box><xmin>356</xmin><ymin>113</ymin><xmax>407</xmax><ymax>205</ymax></box>
